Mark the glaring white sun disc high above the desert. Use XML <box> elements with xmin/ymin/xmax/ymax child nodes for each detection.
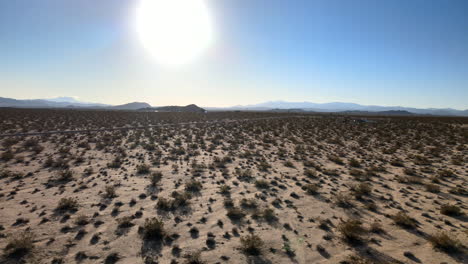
<box><xmin>136</xmin><ymin>0</ymin><xmax>213</xmax><ymax>65</ymax></box>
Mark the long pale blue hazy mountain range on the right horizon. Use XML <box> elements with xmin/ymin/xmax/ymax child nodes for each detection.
<box><xmin>217</xmin><ymin>101</ymin><xmax>468</xmax><ymax>116</ymax></box>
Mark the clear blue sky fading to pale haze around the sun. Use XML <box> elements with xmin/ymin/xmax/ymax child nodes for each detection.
<box><xmin>0</xmin><ymin>0</ymin><xmax>468</xmax><ymax>109</ymax></box>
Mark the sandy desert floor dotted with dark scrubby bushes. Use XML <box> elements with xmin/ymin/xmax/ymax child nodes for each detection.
<box><xmin>0</xmin><ymin>109</ymin><xmax>468</xmax><ymax>264</ymax></box>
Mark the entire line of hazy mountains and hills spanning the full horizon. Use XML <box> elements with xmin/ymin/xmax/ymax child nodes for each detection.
<box><xmin>0</xmin><ymin>97</ymin><xmax>468</xmax><ymax>116</ymax></box>
